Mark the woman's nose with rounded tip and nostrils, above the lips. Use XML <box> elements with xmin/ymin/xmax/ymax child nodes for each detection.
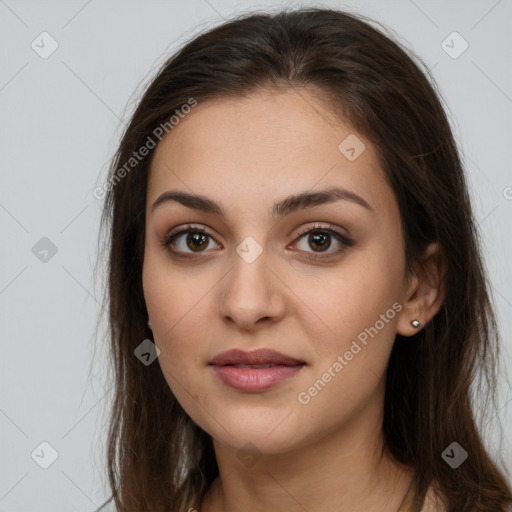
<box><xmin>218</xmin><ymin>248</ymin><xmax>286</xmax><ymax>331</ymax></box>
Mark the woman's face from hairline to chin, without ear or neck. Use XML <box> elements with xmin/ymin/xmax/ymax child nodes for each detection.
<box><xmin>143</xmin><ymin>91</ymin><xmax>412</xmax><ymax>454</ymax></box>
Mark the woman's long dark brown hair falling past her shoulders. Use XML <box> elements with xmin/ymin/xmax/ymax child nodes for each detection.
<box><xmin>95</xmin><ymin>8</ymin><xmax>512</xmax><ymax>512</ymax></box>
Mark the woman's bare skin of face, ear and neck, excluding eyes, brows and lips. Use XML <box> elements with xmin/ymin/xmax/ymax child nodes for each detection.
<box><xmin>143</xmin><ymin>90</ymin><xmax>443</xmax><ymax>512</ymax></box>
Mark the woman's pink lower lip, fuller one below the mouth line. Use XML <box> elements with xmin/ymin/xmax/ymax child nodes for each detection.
<box><xmin>212</xmin><ymin>364</ymin><xmax>304</xmax><ymax>393</ymax></box>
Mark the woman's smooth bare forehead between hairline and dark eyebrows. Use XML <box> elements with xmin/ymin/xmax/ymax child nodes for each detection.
<box><xmin>148</xmin><ymin>90</ymin><xmax>393</xmax><ymax>218</ymax></box>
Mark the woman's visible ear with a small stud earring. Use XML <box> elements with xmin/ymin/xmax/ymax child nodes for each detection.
<box><xmin>397</xmin><ymin>242</ymin><xmax>447</xmax><ymax>336</ymax></box>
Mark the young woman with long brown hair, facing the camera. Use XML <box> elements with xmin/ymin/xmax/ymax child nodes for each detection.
<box><xmin>95</xmin><ymin>8</ymin><xmax>512</xmax><ymax>512</ymax></box>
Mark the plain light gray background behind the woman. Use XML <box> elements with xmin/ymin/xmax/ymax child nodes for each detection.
<box><xmin>0</xmin><ymin>0</ymin><xmax>512</xmax><ymax>512</ymax></box>
